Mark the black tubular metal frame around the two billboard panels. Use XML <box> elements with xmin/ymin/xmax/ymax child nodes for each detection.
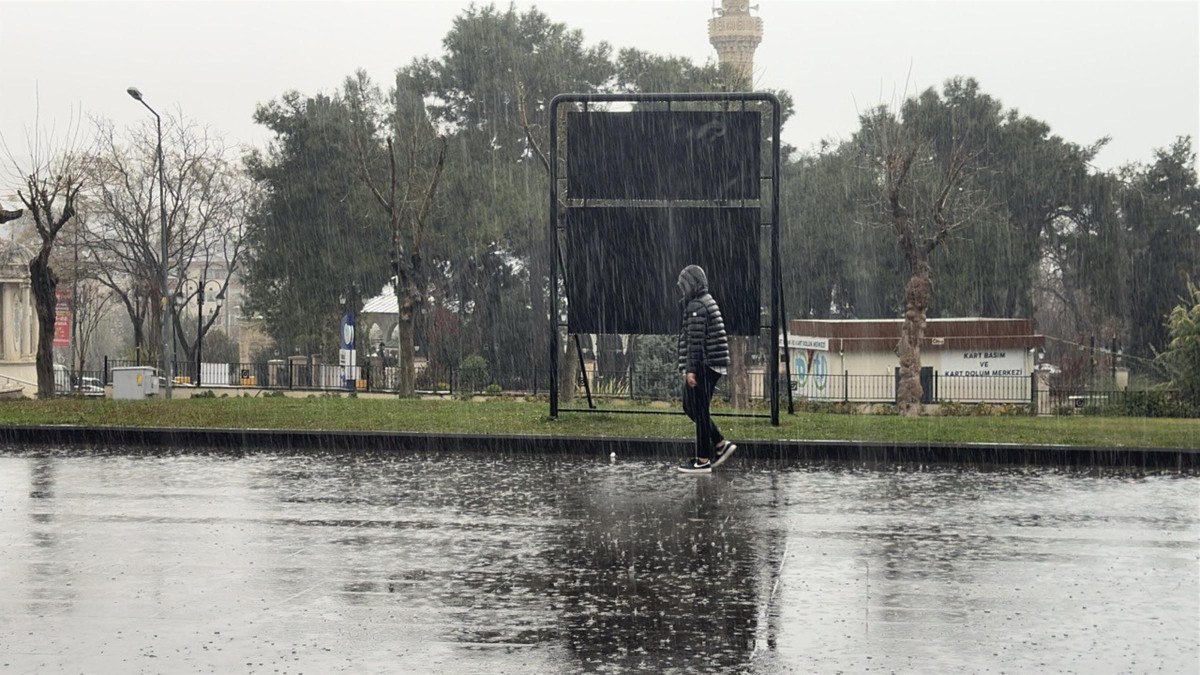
<box><xmin>547</xmin><ymin>91</ymin><xmax>794</xmax><ymax>426</ymax></box>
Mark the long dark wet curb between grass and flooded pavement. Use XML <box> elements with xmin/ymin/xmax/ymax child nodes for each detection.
<box><xmin>0</xmin><ymin>425</ymin><xmax>1200</xmax><ymax>473</ymax></box>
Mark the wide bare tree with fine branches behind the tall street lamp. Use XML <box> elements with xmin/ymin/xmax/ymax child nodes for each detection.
<box><xmin>85</xmin><ymin>114</ymin><xmax>250</xmax><ymax>369</ymax></box>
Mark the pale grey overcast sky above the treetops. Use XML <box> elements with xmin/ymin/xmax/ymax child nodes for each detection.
<box><xmin>0</xmin><ymin>0</ymin><xmax>1200</xmax><ymax>168</ymax></box>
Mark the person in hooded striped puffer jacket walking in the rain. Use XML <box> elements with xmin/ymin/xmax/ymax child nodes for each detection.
<box><xmin>676</xmin><ymin>264</ymin><xmax>738</xmax><ymax>473</ymax></box>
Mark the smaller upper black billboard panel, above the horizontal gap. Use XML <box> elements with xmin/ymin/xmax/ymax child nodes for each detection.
<box><xmin>566</xmin><ymin>110</ymin><xmax>762</xmax><ymax>199</ymax></box>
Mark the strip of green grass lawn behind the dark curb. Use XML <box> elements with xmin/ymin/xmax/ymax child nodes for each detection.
<box><xmin>0</xmin><ymin>398</ymin><xmax>1200</xmax><ymax>448</ymax></box>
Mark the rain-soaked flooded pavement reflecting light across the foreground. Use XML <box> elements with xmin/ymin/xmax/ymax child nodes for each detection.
<box><xmin>0</xmin><ymin>446</ymin><xmax>1200</xmax><ymax>673</ymax></box>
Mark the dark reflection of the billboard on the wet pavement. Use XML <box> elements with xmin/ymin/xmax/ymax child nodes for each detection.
<box><xmin>551</xmin><ymin>474</ymin><xmax>758</xmax><ymax>671</ymax></box>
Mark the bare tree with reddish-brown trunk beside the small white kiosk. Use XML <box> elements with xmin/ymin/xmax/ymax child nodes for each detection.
<box><xmin>863</xmin><ymin>108</ymin><xmax>983</xmax><ymax>417</ymax></box>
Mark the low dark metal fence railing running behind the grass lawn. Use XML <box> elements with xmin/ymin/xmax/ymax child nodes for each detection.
<box><xmin>65</xmin><ymin>359</ymin><xmax>1189</xmax><ymax>416</ymax></box>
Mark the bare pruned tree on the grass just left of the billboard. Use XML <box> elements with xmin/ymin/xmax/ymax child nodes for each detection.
<box><xmin>346</xmin><ymin>72</ymin><xmax>446</xmax><ymax>396</ymax></box>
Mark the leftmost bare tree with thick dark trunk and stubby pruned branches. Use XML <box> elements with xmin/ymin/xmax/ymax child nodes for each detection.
<box><xmin>5</xmin><ymin>120</ymin><xmax>85</xmax><ymax>398</ymax></box>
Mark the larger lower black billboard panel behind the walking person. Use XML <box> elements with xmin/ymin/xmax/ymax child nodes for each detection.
<box><xmin>565</xmin><ymin>207</ymin><xmax>761</xmax><ymax>335</ymax></box>
